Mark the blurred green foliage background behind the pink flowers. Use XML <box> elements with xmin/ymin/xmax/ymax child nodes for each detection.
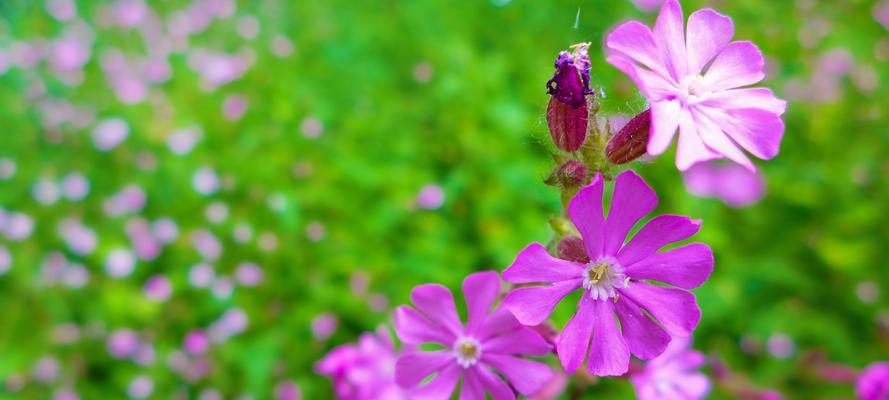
<box><xmin>0</xmin><ymin>0</ymin><xmax>889</xmax><ymax>399</ymax></box>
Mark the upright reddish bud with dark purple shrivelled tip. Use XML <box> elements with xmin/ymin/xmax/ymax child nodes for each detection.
<box><xmin>546</xmin><ymin>44</ymin><xmax>593</xmax><ymax>152</ymax></box>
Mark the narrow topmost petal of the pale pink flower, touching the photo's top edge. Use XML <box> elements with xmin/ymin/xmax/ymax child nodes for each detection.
<box><xmin>654</xmin><ymin>0</ymin><xmax>688</xmax><ymax>82</ymax></box>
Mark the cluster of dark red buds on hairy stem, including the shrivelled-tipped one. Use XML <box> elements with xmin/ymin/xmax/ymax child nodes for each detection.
<box><xmin>546</xmin><ymin>43</ymin><xmax>651</xmax><ymax>188</ymax></box>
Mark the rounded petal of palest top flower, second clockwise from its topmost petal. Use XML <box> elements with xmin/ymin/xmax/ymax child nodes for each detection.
<box><xmin>704</xmin><ymin>41</ymin><xmax>765</xmax><ymax>92</ymax></box>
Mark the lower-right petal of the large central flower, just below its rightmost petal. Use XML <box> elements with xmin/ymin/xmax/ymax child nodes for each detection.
<box><xmin>620</xmin><ymin>282</ymin><xmax>701</xmax><ymax>336</ymax></box>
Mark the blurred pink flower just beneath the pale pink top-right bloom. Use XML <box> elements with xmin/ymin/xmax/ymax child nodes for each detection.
<box><xmin>682</xmin><ymin>161</ymin><xmax>766</xmax><ymax>207</ymax></box>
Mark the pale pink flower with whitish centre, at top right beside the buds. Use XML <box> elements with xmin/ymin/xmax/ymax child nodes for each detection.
<box><xmin>605</xmin><ymin>0</ymin><xmax>786</xmax><ymax>171</ymax></box>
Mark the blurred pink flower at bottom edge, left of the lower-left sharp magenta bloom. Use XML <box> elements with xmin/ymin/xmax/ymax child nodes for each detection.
<box><xmin>315</xmin><ymin>327</ymin><xmax>408</xmax><ymax>400</ymax></box>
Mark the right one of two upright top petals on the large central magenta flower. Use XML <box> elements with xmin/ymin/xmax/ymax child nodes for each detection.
<box><xmin>604</xmin><ymin>170</ymin><xmax>658</xmax><ymax>256</ymax></box>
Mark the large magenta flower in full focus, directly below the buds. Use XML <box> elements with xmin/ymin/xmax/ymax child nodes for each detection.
<box><xmin>503</xmin><ymin>171</ymin><xmax>713</xmax><ymax>376</ymax></box>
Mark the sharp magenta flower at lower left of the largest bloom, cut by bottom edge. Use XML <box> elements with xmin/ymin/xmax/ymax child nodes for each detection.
<box><xmin>395</xmin><ymin>271</ymin><xmax>552</xmax><ymax>399</ymax></box>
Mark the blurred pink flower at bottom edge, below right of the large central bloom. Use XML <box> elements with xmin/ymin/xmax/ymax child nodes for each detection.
<box><xmin>630</xmin><ymin>338</ymin><xmax>710</xmax><ymax>400</ymax></box>
